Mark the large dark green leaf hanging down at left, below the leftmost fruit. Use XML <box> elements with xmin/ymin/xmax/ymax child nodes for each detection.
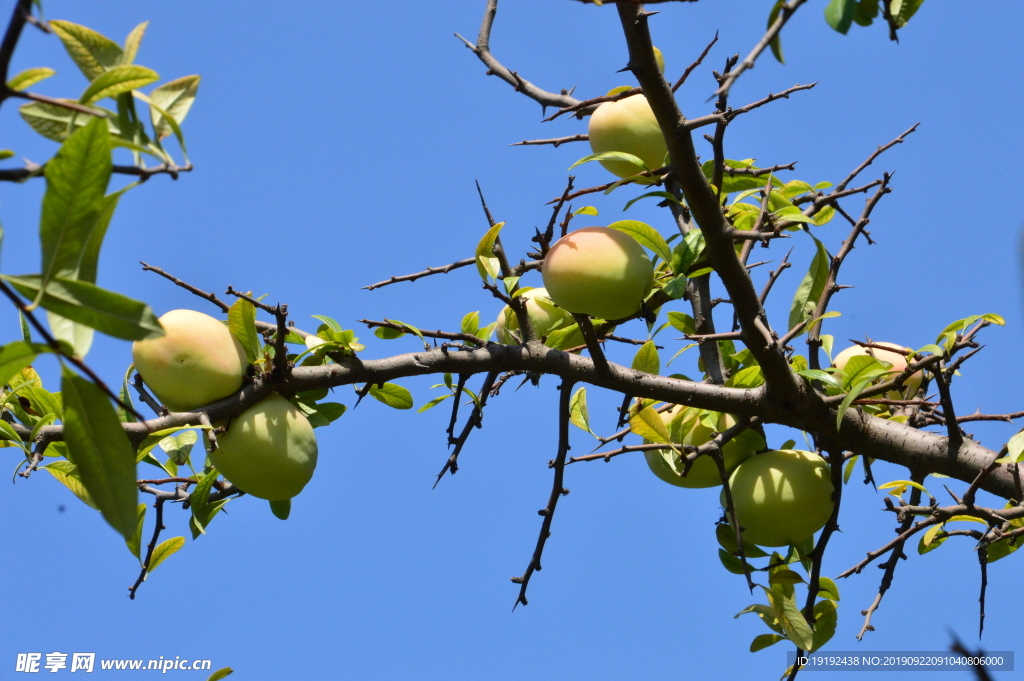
<box><xmin>60</xmin><ymin>369</ymin><xmax>138</xmax><ymax>539</ymax></box>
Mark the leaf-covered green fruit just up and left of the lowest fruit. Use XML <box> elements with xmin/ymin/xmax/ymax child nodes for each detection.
<box><xmin>644</xmin><ymin>405</ymin><xmax>755</xmax><ymax>488</ymax></box>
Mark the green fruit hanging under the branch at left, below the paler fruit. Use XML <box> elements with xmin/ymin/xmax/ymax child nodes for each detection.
<box><xmin>210</xmin><ymin>393</ymin><xmax>316</xmax><ymax>501</ymax></box>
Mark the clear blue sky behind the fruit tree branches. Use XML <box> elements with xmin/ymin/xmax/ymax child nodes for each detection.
<box><xmin>0</xmin><ymin>0</ymin><xmax>1024</xmax><ymax>681</ymax></box>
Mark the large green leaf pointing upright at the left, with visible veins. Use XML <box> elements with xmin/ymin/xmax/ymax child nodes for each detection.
<box><xmin>39</xmin><ymin>114</ymin><xmax>112</xmax><ymax>294</ymax></box>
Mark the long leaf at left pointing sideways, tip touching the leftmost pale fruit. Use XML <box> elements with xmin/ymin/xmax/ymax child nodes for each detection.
<box><xmin>0</xmin><ymin>274</ymin><xmax>164</xmax><ymax>340</ymax></box>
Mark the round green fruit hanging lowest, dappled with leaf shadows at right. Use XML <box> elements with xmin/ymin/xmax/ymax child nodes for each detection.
<box><xmin>721</xmin><ymin>450</ymin><xmax>835</xmax><ymax>546</ymax></box>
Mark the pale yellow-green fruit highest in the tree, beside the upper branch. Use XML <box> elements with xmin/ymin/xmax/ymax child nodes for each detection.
<box><xmin>587</xmin><ymin>94</ymin><xmax>669</xmax><ymax>177</ymax></box>
